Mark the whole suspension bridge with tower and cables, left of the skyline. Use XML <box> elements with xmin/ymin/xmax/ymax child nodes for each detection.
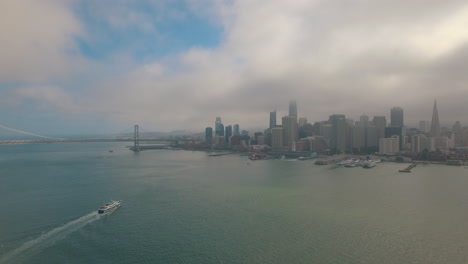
<box><xmin>0</xmin><ymin>125</ymin><xmax>177</xmax><ymax>152</ymax></box>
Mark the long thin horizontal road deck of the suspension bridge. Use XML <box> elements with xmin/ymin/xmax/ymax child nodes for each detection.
<box><xmin>0</xmin><ymin>138</ymin><xmax>173</xmax><ymax>145</ymax></box>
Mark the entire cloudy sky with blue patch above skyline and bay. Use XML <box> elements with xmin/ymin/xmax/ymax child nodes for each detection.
<box><xmin>0</xmin><ymin>0</ymin><xmax>468</xmax><ymax>135</ymax></box>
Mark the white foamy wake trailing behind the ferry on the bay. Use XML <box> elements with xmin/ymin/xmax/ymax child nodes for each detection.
<box><xmin>0</xmin><ymin>212</ymin><xmax>101</xmax><ymax>264</ymax></box>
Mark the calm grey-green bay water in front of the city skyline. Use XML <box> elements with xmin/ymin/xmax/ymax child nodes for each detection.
<box><xmin>0</xmin><ymin>142</ymin><xmax>468</xmax><ymax>263</ymax></box>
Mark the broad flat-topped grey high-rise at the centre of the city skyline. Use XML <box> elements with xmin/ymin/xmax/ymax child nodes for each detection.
<box><xmin>329</xmin><ymin>115</ymin><xmax>348</xmax><ymax>154</ymax></box>
